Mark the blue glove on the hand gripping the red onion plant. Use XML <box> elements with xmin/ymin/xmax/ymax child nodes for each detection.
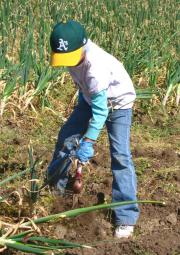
<box><xmin>76</xmin><ymin>140</ymin><xmax>94</xmax><ymax>163</ymax></box>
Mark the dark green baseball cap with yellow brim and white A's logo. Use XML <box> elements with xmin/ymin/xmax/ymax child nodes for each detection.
<box><xmin>50</xmin><ymin>20</ymin><xmax>87</xmax><ymax>66</ymax></box>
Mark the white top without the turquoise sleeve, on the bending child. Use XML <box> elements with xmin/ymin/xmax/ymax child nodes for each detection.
<box><xmin>69</xmin><ymin>40</ymin><xmax>136</xmax><ymax>109</ymax></box>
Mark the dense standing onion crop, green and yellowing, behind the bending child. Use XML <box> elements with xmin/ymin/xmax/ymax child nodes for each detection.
<box><xmin>0</xmin><ymin>0</ymin><xmax>180</xmax><ymax>115</ymax></box>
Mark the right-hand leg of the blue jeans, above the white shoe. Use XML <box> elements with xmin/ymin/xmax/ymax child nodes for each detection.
<box><xmin>106</xmin><ymin>109</ymin><xmax>139</xmax><ymax>225</ymax></box>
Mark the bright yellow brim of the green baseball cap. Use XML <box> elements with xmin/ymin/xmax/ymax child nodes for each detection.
<box><xmin>50</xmin><ymin>47</ymin><xmax>83</xmax><ymax>66</ymax></box>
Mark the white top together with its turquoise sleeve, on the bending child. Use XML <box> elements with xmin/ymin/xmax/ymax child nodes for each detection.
<box><xmin>68</xmin><ymin>40</ymin><xmax>136</xmax><ymax>140</ymax></box>
